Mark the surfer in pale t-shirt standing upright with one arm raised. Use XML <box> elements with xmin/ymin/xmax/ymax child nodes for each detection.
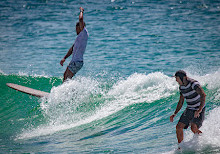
<box><xmin>60</xmin><ymin>7</ymin><xmax>89</xmax><ymax>82</ymax></box>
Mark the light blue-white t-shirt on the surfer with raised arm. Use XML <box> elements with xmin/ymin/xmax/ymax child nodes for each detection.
<box><xmin>71</xmin><ymin>27</ymin><xmax>89</xmax><ymax>62</ymax></box>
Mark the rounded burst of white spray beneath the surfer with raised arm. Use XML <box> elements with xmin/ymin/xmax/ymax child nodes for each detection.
<box><xmin>41</xmin><ymin>77</ymin><xmax>102</xmax><ymax>124</ymax></box>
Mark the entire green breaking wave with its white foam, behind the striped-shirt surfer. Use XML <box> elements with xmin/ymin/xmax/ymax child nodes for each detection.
<box><xmin>0</xmin><ymin>72</ymin><xmax>220</xmax><ymax>153</ymax></box>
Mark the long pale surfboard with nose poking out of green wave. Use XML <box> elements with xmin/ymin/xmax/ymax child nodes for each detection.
<box><xmin>6</xmin><ymin>83</ymin><xmax>49</xmax><ymax>97</ymax></box>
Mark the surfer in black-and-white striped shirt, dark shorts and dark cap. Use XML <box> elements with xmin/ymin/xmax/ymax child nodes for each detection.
<box><xmin>170</xmin><ymin>70</ymin><xmax>206</xmax><ymax>144</ymax></box>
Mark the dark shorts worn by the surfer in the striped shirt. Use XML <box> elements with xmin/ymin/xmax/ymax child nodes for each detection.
<box><xmin>179</xmin><ymin>107</ymin><xmax>205</xmax><ymax>129</ymax></box>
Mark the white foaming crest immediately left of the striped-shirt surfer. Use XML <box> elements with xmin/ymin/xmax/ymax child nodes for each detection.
<box><xmin>108</xmin><ymin>72</ymin><xmax>178</xmax><ymax>104</ymax></box>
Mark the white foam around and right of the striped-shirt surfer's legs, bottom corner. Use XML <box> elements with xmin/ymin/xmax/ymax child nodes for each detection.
<box><xmin>162</xmin><ymin>107</ymin><xmax>220</xmax><ymax>154</ymax></box>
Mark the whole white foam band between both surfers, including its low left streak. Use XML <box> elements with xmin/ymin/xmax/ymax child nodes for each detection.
<box><xmin>18</xmin><ymin>72</ymin><xmax>178</xmax><ymax>139</ymax></box>
